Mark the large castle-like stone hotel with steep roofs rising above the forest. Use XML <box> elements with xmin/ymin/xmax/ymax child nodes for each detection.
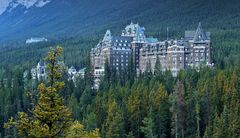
<box><xmin>91</xmin><ymin>23</ymin><xmax>212</xmax><ymax>78</ymax></box>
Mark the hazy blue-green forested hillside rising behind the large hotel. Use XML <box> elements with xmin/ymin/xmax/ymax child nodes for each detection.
<box><xmin>0</xmin><ymin>0</ymin><xmax>240</xmax><ymax>67</ymax></box>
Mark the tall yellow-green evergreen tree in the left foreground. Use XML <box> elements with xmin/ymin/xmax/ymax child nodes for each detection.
<box><xmin>5</xmin><ymin>47</ymin><xmax>72</xmax><ymax>137</ymax></box>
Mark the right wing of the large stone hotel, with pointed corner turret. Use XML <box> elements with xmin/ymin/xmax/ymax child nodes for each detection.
<box><xmin>139</xmin><ymin>23</ymin><xmax>212</xmax><ymax>76</ymax></box>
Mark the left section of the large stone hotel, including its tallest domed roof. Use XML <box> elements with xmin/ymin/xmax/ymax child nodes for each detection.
<box><xmin>91</xmin><ymin>23</ymin><xmax>146</xmax><ymax>74</ymax></box>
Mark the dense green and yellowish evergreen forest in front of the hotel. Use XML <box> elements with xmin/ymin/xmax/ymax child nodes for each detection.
<box><xmin>0</xmin><ymin>43</ymin><xmax>240</xmax><ymax>138</ymax></box>
